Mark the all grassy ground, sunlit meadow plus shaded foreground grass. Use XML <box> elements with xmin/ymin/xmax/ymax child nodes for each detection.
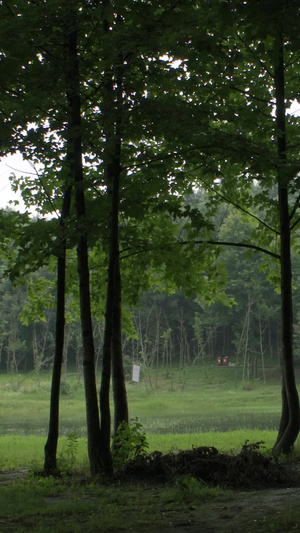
<box><xmin>0</xmin><ymin>365</ymin><xmax>300</xmax><ymax>533</ymax></box>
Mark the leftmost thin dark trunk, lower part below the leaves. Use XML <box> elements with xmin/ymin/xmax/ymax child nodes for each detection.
<box><xmin>44</xmin><ymin>187</ymin><xmax>71</xmax><ymax>474</ymax></box>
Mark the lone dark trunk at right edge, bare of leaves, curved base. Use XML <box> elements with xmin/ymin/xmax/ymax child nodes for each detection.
<box><xmin>273</xmin><ymin>36</ymin><xmax>300</xmax><ymax>455</ymax></box>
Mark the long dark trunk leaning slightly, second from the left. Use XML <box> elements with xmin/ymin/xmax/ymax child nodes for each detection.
<box><xmin>66</xmin><ymin>10</ymin><xmax>105</xmax><ymax>476</ymax></box>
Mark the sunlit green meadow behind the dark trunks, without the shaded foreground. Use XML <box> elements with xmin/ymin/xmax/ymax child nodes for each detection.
<box><xmin>0</xmin><ymin>365</ymin><xmax>292</xmax><ymax>470</ymax></box>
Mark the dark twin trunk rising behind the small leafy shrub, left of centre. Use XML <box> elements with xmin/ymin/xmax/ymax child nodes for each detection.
<box><xmin>100</xmin><ymin>0</ymin><xmax>128</xmax><ymax>440</ymax></box>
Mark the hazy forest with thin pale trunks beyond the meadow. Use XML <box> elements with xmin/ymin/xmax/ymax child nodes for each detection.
<box><xmin>0</xmin><ymin>196</ymin><xmax>300</xmax><ymax>380</ymax></box>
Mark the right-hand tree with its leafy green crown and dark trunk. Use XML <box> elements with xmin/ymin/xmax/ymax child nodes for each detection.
<box><xmin>129</xmin><ymin>0</ymin><xmax>299</xmax><ymax>454</ymax></box>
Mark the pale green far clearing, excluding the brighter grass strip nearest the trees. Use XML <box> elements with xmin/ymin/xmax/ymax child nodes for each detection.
<box><xmin>0</xmin><ymin>366</ymin><xmax>281</xmax><ymax>437</ymax></box>
